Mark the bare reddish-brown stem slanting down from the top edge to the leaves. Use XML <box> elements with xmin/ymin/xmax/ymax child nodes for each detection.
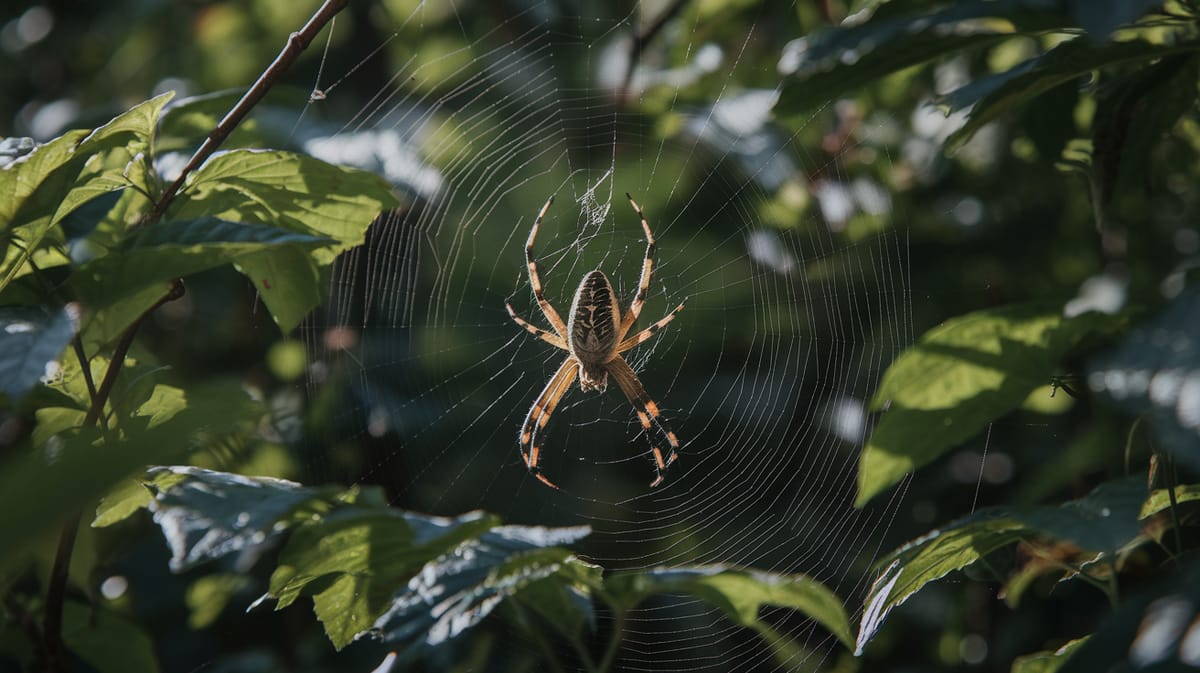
<box><xmin>146</xmin><ymin>0</ymin><xmax>349</xmax><ymax>222</ymax></box>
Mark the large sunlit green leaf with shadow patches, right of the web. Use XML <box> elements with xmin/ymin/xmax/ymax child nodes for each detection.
<box><xmin>856</xmin><ymin>306</ymin><xmax>1114</xmax><ymax>506</ymax></box>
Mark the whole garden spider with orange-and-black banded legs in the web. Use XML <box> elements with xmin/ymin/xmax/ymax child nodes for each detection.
<box><xmin>504</xmin><ymin>193</ymin><xmax>683</xmax><ymax>488</ymax></box>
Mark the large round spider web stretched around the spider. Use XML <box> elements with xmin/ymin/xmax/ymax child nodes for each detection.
<box><xmin>292</xmin><ymin>2</ymin><xmax>911</xmax><ymax>671</ymax></box>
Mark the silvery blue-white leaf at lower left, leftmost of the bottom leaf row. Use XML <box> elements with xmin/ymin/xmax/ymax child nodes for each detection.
<box><xmin>150</xmin><ymin>465</ymin><xmax>336</xmax><ymax>572</ymax></box>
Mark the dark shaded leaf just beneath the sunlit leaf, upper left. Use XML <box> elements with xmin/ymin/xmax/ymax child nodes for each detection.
<box><xmin>68</xmin><ymin>217</ymin><xmax>330</xmax><ymax>320</ymax></box>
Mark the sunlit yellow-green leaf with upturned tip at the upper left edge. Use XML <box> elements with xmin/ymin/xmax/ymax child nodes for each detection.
<box><xmin>0</xmin><ymin>92</ymin><xmax>174</xmax><ymax>289</ymax></box>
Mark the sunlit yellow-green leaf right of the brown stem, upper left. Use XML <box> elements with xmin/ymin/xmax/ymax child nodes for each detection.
<box><xmin>169</xmin><ymin>150</ymin><xmax>398</xmax><ymax>266</ymax></box>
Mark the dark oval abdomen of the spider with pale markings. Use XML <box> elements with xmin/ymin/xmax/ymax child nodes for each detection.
<box><xmin>566</xmin><ymin>271</ymin><xmax>620</xmax><ymax>387</ymax></box>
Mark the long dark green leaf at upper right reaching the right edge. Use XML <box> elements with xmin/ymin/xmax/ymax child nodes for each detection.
<box><xmin>940</xmin><ymin>37</ymin><xmax>1200</xmax><ymax>149</ymax></box>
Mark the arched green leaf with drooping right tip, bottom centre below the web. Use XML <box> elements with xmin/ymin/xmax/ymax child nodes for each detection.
<box><xmin>605</xmin><ymin>565</ymin><xmax>852</xmax><ymax>647</ymax></box>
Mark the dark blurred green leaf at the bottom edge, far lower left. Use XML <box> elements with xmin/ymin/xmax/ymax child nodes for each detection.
<box><xmin>62</xmin><ymin>601</ymin><xmax>158</xmax><ymax>673</ymax></box>
